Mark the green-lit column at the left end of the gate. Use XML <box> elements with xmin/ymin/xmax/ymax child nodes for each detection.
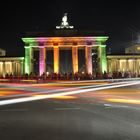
<box><xmin>24</xmin><ymin>47</ymin><xmax>33</xmax><ymax>74</ymax></box>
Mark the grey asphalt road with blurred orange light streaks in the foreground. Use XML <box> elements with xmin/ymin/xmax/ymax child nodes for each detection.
<box><xmin>0</xmin><ymin>80</ymin><xmax>140</xmax><ymax>140</ymax></box>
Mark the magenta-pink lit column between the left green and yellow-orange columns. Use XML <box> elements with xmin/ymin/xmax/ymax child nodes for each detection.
<box><xmin>39</xmin><ymin>47</ymin><xmax>46</xmax><ymax>76</ymax></box>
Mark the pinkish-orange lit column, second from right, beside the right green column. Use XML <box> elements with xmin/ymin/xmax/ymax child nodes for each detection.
<box><xmin>85</xmin><ymin>46</ymin><xmax>92</xmax><ymax>74</ymax></box>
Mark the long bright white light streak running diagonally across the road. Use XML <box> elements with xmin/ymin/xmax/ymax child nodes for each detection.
<box><xmin>0</xmin><ymin>82</ymin><xmax>140</xmax><ymax>106</ymax></box>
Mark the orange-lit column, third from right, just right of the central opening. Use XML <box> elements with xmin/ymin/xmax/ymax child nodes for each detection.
<box><xmin>72</xmin><ymin>46</ymin><xmax>78</xmax><ymax>73</ymax></box>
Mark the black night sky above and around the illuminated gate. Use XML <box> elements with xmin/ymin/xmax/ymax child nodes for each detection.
<box><xmin>0</xmin><ymin>0</ymin><xmax>140</xmax><ymax>56</ymax></box>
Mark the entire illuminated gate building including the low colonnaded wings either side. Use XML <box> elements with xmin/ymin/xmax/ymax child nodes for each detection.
<box><xmin>0</xmin><ymin>13</ymin><xmax>140</xmax><ymax>76</ymax></box>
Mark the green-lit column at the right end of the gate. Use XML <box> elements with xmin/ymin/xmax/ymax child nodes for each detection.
<box><xmin>98</xmin><ymin>45</ymin><xmax>107</xmax><ymax>73</ymax></box>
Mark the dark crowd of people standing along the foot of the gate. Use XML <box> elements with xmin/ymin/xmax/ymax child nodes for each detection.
<box><xmin>1</xmin><ymin>72</ymin><xmax>140</xmax><ymax>81</ymax></box>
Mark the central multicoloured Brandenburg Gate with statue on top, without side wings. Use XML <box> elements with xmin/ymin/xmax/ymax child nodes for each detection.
<box><xmin>22</xmin><ymin>13</ymin><xmax>108</xmax><ymax>75</ymax></box>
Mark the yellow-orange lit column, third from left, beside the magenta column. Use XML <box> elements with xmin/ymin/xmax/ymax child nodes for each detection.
<box><xmin>53</xmin><ymin>46</ymin><xmax>59</xmax><ymax>73</ymax></box>
